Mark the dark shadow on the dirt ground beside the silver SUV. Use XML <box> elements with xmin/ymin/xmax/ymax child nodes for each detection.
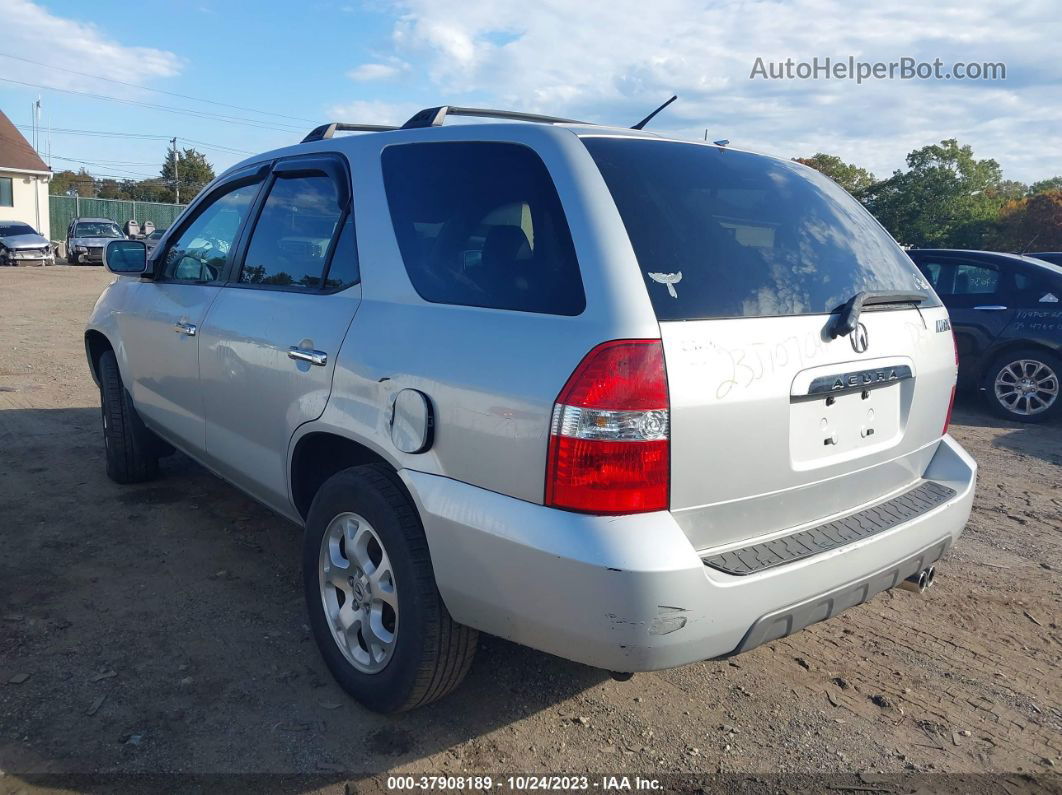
<box><xmin>0</xmin><ymin>408</ymin><xmax>611</xmax><ymax>791</ymax></box>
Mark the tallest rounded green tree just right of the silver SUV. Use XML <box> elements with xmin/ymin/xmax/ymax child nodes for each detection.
<box><xmin>861</xmin><ymin>138</ymin><xmax>1013</xmax><ymax>248</ymax></box>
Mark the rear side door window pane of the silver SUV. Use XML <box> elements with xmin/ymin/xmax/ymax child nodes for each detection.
<box><xmin>239</xmin><ymin>174</ymin><xmax>342</xmax><ymax>290</ymax></box>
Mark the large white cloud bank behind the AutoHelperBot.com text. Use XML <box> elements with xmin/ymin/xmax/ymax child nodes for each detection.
<box><xmin>352</xmin><ymin>0</ymin><xmax>1062</xmax><ymax>180</ymax></box>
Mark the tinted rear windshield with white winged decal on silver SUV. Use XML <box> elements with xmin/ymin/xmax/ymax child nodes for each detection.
<box><xmin>583</xmin><ymin>137</ymin><xmax>938</xmax><ymax>321</ymax></box>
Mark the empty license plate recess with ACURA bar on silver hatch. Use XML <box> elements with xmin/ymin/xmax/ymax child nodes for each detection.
<box><xmin>789</xmin><ymin>364</ymin><xmax>914</xmax><ymax>470</ymax></box>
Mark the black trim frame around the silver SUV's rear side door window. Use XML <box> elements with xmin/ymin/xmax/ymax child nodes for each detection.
<box><xmin>225</xmin><ymin>152</ymin><xmax>361</xmax><ymax>295</ymax></box>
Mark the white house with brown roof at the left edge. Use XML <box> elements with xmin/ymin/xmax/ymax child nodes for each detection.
<box><xmin>0</xmin><ymin>110</ymin><xmax>52</xmax><ymax>238</ymax></box>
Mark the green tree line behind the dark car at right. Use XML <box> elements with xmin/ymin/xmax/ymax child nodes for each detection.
<box><xmin>793</xmin><ymin>138</ymin><xmax>1062</xmax><ymax>252</ymax></box>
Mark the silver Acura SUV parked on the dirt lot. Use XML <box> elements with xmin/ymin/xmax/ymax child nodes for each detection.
<box><xmin>85</xmin><ymin>107</ymin><xmax>976</xmax><ymax>711</ymax></box>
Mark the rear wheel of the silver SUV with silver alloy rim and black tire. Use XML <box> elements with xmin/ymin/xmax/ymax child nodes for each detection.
<box><xmin>303</xmin><ymin>464</ymin><xmax>478</xmax><ymax>712</ymax></box>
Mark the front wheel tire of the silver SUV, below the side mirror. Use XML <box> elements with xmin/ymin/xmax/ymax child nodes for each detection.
<box><xmin>100</xmin><ymin>350</ymin><xmax>160</xmax><ymax>483</ymax></box>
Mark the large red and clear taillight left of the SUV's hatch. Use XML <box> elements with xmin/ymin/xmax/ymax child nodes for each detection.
<box><xmin>546</xmin><ymin>340</ymin><xmax>671</xmax><ymax>514</ymax></box>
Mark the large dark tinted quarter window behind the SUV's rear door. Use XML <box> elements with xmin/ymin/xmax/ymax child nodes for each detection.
<box><xmin>383</xmin><ymin>142</ymin><xmax>586</xmax><ymax>315</ymax></box>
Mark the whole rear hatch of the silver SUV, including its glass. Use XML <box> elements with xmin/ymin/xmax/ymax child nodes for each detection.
<box><xmin>584</xmin><ymin>137</ymin><xmax>956</xmax><ymax>549</ymax></box>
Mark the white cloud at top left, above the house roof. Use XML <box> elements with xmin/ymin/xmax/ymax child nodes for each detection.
<box><xmin>0</xmin><ymin>0</ymin><xmax>182</xmax><ymax>94</ymax></box>
